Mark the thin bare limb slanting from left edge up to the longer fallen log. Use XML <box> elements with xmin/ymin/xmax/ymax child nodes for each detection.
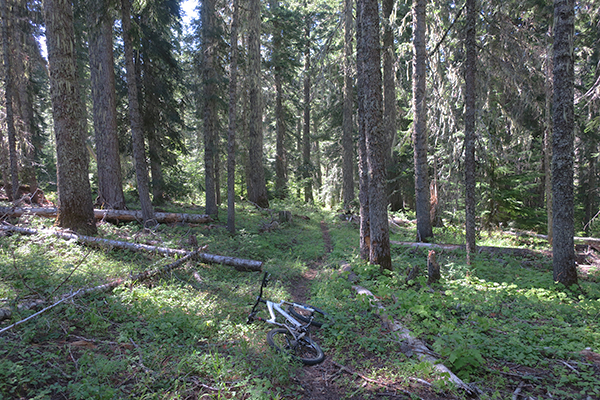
<box><xmin>0</xmin><ymin>250</ymin><xmax>198</xmax><ymax>334</ymax></box>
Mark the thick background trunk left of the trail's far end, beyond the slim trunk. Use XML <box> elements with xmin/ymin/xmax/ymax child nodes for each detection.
<box><xmin>248</xmin><ymin>0</ymin><xmax>269</xmax><ymax>208</ymax></box>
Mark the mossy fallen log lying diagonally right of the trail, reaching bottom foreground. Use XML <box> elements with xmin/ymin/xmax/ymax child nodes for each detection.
<box><xmin>343</xmin><ymin>264</ymin><xmax>477</xmax><ymax>396</ymax></box>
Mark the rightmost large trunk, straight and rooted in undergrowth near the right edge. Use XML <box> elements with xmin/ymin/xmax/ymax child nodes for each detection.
<box><xmin>552</xmin><ymin>0</ymin><xmax>577</xmax><ymax>287</ymax></box>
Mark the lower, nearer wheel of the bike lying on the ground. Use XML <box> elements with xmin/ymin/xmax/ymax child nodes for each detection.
<box><xmin>267</xmin><ymin>328</ymin><xmax>325</xmax><ymax>365</ymax></box>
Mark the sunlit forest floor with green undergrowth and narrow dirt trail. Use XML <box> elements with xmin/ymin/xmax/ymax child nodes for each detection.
<box><xmin>0</xmin><ymin>203</ymin><xmax>600</xmax><ymax>400</ymax></box>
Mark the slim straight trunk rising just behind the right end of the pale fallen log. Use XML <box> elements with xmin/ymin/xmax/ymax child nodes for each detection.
<box><xmin>200</xmin><ymin>0</ymin><xmax>218</xmax><ymax>215</ymax></box>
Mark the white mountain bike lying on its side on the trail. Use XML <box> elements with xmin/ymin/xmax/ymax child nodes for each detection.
<box><xmin>247</xmin><ymin>272</ymin><xmax>327</xmax><ymax>365</ymax></box>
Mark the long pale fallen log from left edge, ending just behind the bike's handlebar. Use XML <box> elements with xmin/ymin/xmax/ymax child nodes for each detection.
<box><xmin>0</xmin><ymin>225</ymin><xmax>263</xmax><ymax>271</ymax></box>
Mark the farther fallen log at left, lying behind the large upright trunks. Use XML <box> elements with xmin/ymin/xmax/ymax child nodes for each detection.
<box><xmin>0</xmin><ymin>207</ymin><xmax>213</xmax><ymax>224</ymax></box>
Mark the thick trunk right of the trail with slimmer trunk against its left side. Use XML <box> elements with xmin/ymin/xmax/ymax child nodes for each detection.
<box><xmin>356</xmin><ymin>0</ymin><xmax>392</xmax><ymax>270</ymax></box>
